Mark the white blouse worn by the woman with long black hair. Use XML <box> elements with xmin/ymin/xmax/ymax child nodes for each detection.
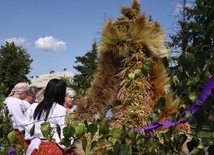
<box><xmin>25</xmin><ymin>103</ymin><xmax>67</xmax><ymax>155</ymax></box>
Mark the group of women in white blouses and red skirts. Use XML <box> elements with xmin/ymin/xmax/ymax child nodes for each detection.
<box><xmin>4</xmin><ymin>79</ymin><xmax>76</xmax><ymax>155</ymax></box>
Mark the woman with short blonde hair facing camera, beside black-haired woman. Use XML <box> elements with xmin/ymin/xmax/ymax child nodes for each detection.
<box><xmin>63</xmin><ymin>87</ymin><xmax>76</xmax><ymax>112</ymax></box>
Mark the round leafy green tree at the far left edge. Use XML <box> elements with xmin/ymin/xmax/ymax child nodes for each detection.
<box><xmin>0</xmin><ymin>42</ymin><xmax>33</xmax><ymax>96</ymax></box>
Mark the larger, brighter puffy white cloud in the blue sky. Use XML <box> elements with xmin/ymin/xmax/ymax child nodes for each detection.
<box><xmin>35</xmin><ymin>36</ymin><xmax>66</xmax><ymax>52</ymax></box>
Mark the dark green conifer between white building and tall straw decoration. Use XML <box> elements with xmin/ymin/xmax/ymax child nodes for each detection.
<box><xmin>72</xmin><ymin>42</ymin><xmax>97</xmax><ymax>96</ymax></box>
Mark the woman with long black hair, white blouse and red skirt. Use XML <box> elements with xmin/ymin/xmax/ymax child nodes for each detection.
<box><xmin>25</xmin><ymin>79</ymin><xmax>73</xmax><ymax>155</ymax></box>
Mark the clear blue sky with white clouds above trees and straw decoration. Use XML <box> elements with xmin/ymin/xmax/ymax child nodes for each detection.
<box><xmin>0</xmin><ymin>0</ymin><xmax>183</xmax><ymax>76</ymax></box>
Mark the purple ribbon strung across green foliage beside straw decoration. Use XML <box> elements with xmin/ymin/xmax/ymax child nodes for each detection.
<box><xmin>134</xmin><ymin>75</ymin><xmax>214</xmax><ymax>136</ymax></box>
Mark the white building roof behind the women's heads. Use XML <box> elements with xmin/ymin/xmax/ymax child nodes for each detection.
<box><xmin>29</xmin><ymin>69</ymin><xmax>74</xmax><ymax>88</ymax></box>
